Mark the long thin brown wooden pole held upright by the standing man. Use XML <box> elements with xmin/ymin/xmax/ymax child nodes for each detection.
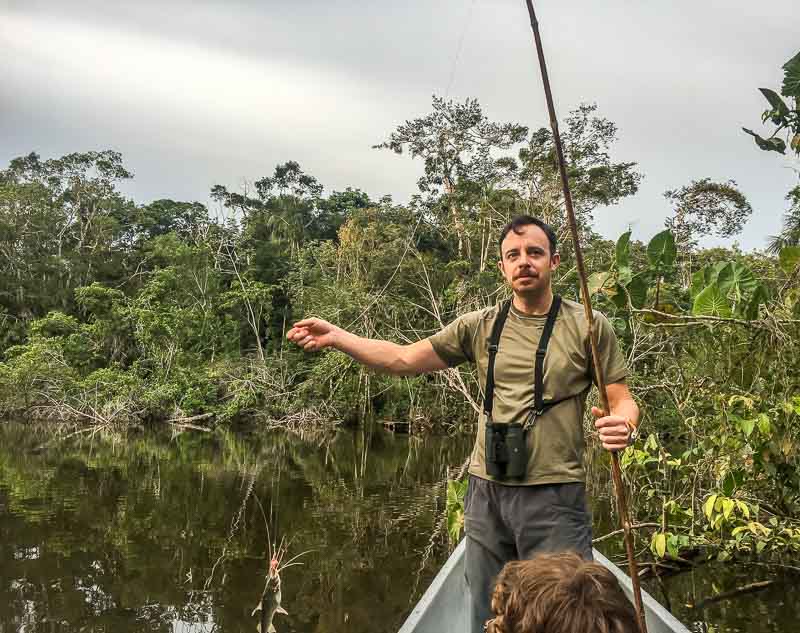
<box><xmin>525</xmin><ymin>0</ymin><xmax>647</xmax><ymax>633</ymax></box>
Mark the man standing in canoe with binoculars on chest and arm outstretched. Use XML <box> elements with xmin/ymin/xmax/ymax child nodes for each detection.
<box><xmin>287</xmin><ymin>216</ymin><xmax>639</xmax><ymax>633</ymax></box>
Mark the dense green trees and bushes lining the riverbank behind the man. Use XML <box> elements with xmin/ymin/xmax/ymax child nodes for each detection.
<box><xmin>0</xmin><ymin>56</ymin><xmax>800</xmax><ymax>564</ymax></box>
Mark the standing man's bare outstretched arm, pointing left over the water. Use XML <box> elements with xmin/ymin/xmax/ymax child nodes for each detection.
<box><xmin>286</xmin><ymin>319</ymin><xmax>447</xmax><ymax>376</ymax></box>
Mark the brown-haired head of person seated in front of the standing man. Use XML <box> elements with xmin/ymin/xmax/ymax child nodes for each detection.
<box><xmin>486</xmin><ymin>552</ymin><xmax>639</xmax><ymax>633</ymax></box>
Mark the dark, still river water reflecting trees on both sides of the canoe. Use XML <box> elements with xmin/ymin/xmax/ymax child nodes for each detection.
<box><xmin>0</xmin><ymin>423</ymin><xmax>800</xmax><ymax>633</ymax></box>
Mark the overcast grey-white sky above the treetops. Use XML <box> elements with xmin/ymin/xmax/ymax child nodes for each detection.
<box><xmin>0</xmin><ymin>0</ymin><xmax>800</xmax><ymax>249</ymax></box>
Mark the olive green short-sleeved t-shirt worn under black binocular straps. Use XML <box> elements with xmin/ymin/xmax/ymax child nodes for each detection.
<box><xmin>428</xmin><ymin>299</ymin><xmax>627</xmax><ymax>485</ymax></box>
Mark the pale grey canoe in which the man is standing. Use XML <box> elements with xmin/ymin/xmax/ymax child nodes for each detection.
<box><xmin>400</xmin><ymin>539</ymin><xmax>690</xmax><ymax>633</ymax></box>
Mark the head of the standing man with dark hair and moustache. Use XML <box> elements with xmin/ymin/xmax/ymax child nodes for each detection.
<box><xmin>498</xmin><ymin>224</ymin><xmax>561</xmax><ymax>295</ymax></box>
